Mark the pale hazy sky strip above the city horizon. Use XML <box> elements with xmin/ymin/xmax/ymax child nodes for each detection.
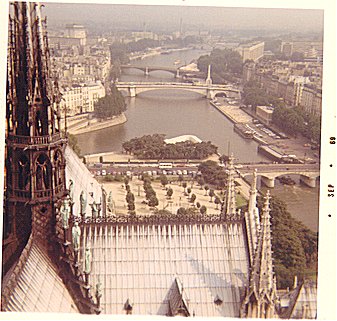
<box><xmin>44</xmin><ymin>3</ymin><xmax>323</xmax><ymax>31</ymax></box>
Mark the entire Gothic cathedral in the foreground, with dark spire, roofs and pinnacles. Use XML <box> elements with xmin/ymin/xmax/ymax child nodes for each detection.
<box><xmin>1</xmin><ymin>2</ymin><xmax>316</xmax><ymax>319</ymax></box>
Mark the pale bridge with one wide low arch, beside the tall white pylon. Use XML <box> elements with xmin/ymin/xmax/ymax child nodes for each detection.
<box><xmin>116</xmin><ymin>82</ymin><xmax>240</xmax><ymax>99</ymax></box>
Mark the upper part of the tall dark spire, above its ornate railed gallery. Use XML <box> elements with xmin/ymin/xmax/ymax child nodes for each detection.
<box><xmin>7</xmin><ymin>2</ymin><xmax>56</xmax><ymax>136</ymax></box>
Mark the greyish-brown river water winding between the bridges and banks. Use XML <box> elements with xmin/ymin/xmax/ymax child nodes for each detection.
<box><xmin>78</xmin><ymin>50</ymin><xmax>318</xmax><ymax>231</ymax></box>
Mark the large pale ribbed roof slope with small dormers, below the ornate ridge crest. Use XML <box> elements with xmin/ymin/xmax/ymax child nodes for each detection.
<box><xmin>77</xmin><ymin>222</ymin><xmax>249</xmax><ymax>317</ymax></box>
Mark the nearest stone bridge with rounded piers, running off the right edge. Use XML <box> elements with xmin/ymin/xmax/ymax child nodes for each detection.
<box><xmin>238</xmin><ymin>164</ymin><xmax>320</xmax><ymax>188</ymax></box>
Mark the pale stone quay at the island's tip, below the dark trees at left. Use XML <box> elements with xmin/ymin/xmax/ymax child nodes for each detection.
<box><xmin>68</xmin><ymin>113</ymin><xmax>127</xmax><ymax>135</ymax></box>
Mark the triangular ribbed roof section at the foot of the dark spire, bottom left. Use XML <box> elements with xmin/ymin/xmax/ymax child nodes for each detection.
<box><xmin>2</xmin><ymin>237</ymin><xmax>79</xmax><ymax>313</ymax></box>
